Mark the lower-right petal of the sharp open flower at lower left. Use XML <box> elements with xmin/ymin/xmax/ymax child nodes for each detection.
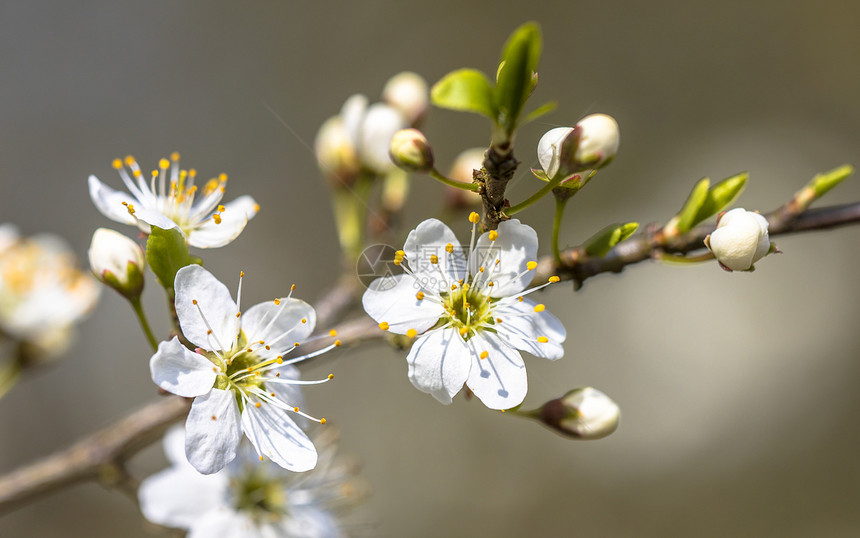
<box><xmin>242</xmin><ymin>402</ymin><xmax>317</xmax><ymax>472</ymax></box>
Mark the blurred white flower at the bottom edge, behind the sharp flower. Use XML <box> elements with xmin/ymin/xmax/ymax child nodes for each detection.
<box><xmin>138</xmin><ymin>427</ymin><xmax>360</xmax><ymax>538</ymax></box>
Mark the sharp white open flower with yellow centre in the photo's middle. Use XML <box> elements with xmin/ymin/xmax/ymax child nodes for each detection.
<box><xmin>362</xmin><ymin>213</ymin><xmax>565</xmax><ymax>409</ymax></box>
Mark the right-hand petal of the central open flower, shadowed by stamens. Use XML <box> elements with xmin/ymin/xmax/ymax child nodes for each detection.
<box><xmin>493</xmin><ymin>299</ymin><xmax>567</xmax><ymax>360</ymax></box>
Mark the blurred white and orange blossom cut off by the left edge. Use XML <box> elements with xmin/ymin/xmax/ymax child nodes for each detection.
<box><xmin>0</xmin><ymin>224</ymin><xmax>99</xmax><ymax>356</ymax></box>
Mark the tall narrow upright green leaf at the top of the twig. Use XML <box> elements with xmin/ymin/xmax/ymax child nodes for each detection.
<box><xmin>496</xmin><ymin>22</ymin><xmax>541</xmax><ymax>136</ymax></box>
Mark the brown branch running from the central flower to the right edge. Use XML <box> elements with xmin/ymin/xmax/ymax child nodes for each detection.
<box><xmin>533</xmin><ymin>200</ymin><xmax>860</xmax><ymax>289</ymax></box>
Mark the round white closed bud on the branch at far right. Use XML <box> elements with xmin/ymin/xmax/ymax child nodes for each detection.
<box><xmin>705</xmin><ymin>208</ymin><xmax>770</xmax><ymax>271</ymax></box>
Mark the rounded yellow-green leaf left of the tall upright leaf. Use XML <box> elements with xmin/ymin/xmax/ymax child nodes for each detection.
<box><xmin>430</xmin><ymin>69</ymin><xmax>498</xmax><ymax>121</ymax></box>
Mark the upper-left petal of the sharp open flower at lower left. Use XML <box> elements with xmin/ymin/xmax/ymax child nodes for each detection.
<box><xmin>173</xmin><ymin>265</ymin><xmax>239</xmax><ymax>351</ymax></box>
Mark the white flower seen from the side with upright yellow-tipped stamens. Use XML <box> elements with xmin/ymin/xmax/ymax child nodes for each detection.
<box><xmin>89</xmin><ymin>153</ymin><xmax>260</xmax><ymax>248</ymax></box>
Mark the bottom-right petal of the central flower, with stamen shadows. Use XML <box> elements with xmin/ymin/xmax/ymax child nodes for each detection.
<box><xmin>466</xmin><ymin>333</ymin><xmax>529</xmax><ymax>409</ymax></box>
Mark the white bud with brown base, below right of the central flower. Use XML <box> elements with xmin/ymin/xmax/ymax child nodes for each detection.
<box><xmin>535</xmin><ymin>387</ymin><xmax>621</xmax><ymax>439</ymax></box>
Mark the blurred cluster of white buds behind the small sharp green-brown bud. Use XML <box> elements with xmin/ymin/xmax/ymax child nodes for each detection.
<box><xmin>314</xmin><ymin>72</ymin><xmax>429</xmax><ymax>186</ymax></box>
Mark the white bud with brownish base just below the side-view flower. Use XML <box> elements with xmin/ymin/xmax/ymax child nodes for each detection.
<box><xmin>89</xmin><ymin>228</ymin><xmax>144</xmax><ymax>299</ymax></box>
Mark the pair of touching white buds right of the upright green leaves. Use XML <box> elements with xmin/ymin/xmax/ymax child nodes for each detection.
<box><xmin>538</xmin><ymin>114</ymin><xmax>619</xmax><ymax>179</ymax></box>
